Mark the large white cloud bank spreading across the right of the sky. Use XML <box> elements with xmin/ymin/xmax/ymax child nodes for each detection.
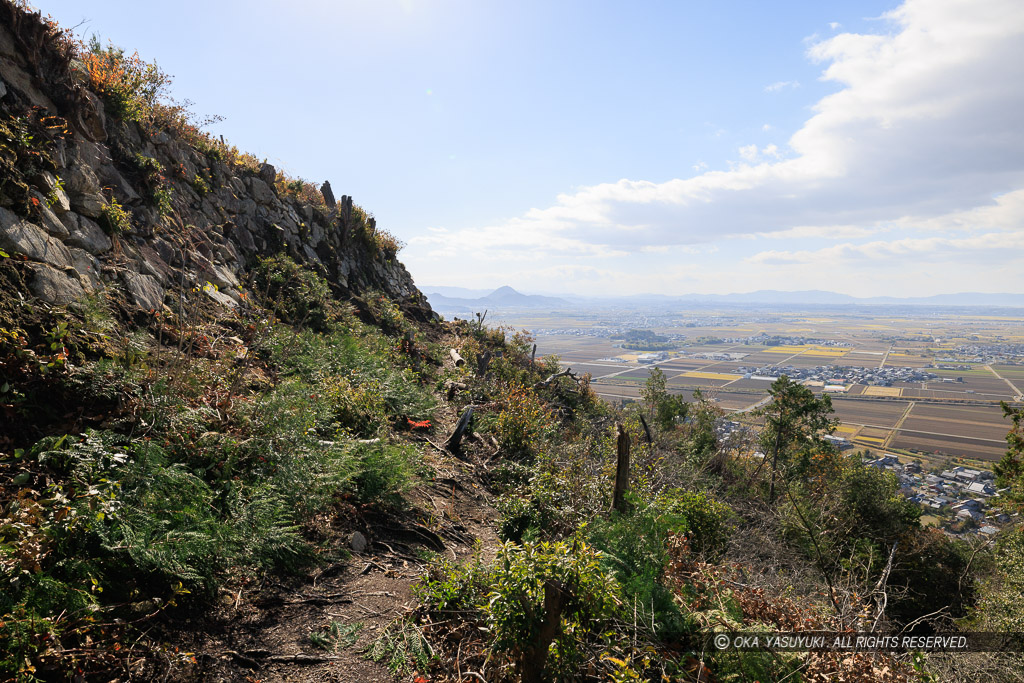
<box><xmin>409</xmin><ymin>0</ymin><xmax>1024</xmax><ymax>290</ymax></box>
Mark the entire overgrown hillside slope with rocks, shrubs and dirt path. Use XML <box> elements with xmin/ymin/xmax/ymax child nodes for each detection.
<box><xmin>0</xmin><ymin>5</ymin><xmax>1024</xmax><ymax>683</ymax></box>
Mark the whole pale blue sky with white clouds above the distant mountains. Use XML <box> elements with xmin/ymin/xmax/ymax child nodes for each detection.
<box><xmin>36</xmin><ymin>0</ymin><xmax>1024</xmax><ymax>296</ymax></box>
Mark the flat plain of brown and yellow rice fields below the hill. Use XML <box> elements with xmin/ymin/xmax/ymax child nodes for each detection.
<box><xmin>502</xmin><ymin>307</ymin><xmax>1024</xmax><ymax>461</ymax></box>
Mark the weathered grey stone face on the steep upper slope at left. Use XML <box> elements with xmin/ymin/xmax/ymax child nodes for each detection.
<box><xmin>0</xmin><ymin>0</ymin><xmax>433</xmax><ymax>318</ymax></box>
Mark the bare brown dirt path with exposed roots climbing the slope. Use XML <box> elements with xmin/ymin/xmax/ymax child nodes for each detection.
<box><xmin>166</xmin><ymin>454</ymin><xmax>498</xmax><ymax>683</ymax></box>
